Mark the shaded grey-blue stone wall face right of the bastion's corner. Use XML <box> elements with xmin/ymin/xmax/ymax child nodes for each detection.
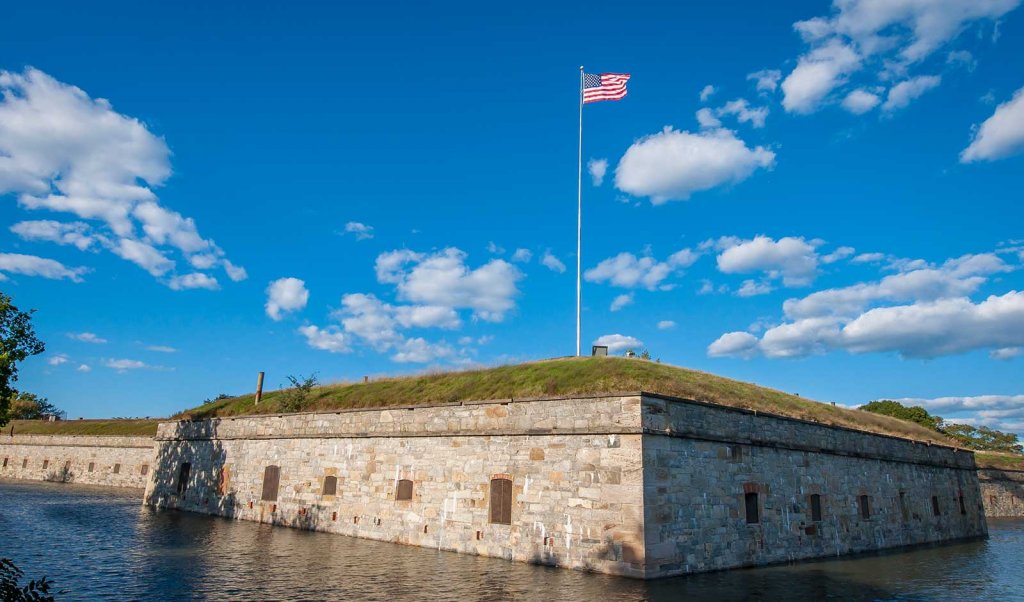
<box><xmin>643</xmin><ymin>395</ymin><xmax>987</xmax><ymax>576</ymax></box>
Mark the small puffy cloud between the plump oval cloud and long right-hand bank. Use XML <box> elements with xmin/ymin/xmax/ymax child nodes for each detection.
<box><xmin>718</xmin><ymin>235</ymin><xmax>818</xmax><ymax>287</ymax></box>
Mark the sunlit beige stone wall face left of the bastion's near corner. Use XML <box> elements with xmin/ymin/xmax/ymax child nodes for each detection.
<box><xmin>145</xmin><ymin>395</ymin><xmax>644</xmax><ymax>576</ymax></box>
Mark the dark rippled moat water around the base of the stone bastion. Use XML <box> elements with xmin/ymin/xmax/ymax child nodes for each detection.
<box><xmin>0</xmin><ymin>481</ymin><xmax>1024</xmax><ymax>602</ymax></box>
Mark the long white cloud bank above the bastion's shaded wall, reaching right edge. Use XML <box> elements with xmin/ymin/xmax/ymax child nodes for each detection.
<box><xmin>709</xmin><ymin>248</ymin><xmax>1024</xmax><ymax>357</ymax></box>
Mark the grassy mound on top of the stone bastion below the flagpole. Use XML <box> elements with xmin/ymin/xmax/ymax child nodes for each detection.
<box><xmin>175</xmin><ymin>357</ymin><xmax>954</xmax><ymax>445</ymax></box>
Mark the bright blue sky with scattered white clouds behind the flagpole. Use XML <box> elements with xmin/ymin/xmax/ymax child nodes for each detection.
<box><xmin>0</xmin><ymin>0</ymin><xmax>1024</xmax><ymax>432</ymax></box>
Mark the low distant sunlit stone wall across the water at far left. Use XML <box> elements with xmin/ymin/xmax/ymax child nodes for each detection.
<box><xmin>0</xmin><ymin>435</ymin><xmax>154</xmax><ymax>488</ymax></box>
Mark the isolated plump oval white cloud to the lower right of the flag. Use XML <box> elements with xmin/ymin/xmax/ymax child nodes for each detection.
<box><xmin>615</xmin><ymin>127</ymin><xmax>775</xmax><ymax>205</ymax></box>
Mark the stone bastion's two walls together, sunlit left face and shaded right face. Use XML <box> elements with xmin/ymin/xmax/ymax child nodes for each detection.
<box><xmin>145</xmin><ymin>393</ymin><xmax>987</xmax><ymax>577</ymax></box>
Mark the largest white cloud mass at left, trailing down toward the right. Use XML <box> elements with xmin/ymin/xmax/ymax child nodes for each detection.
<box><xmin>0</xmin><ymin>69</ymin><xmax>241</xmax><ymax>288</ymax></box>
